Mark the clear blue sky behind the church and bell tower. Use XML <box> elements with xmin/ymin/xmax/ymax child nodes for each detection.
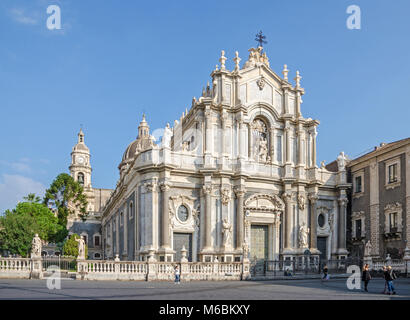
<box><xmin>0</xmin><ymin>0</ymin><xmax>410</xmax><ymax>212</ymax></box>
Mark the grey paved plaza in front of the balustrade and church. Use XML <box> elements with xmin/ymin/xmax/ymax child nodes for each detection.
<box><xmin>0</xmin><ymin>279</ymin><xmax>410</xmax><ymax>300</ymax></box>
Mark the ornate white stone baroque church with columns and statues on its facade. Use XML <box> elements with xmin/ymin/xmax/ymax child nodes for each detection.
<box><xmin>69</xmin><ymin>47</ymin><xmax>350</xmax><ymax>262</ymax></box>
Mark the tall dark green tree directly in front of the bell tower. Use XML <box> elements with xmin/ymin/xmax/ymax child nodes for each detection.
<box><xmin>44</xmin><ymin>173</ymin><xmax>88</xmax><ymax>227</ymax></box>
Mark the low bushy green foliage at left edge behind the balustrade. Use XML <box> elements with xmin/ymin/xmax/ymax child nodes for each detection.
<box><xmin>0</xmin><ymin>194</ymin><xmax>67</xmax><ymax>256</ymax></box>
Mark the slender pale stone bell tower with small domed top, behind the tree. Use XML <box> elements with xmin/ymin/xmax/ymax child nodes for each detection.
<box><xmin>69</xmin><ymin>129</ymin><xmax>92</xmax><ymax>190</ymax></box>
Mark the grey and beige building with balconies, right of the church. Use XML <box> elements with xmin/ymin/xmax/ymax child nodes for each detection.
<box><xmin>347</xmin><ymin>138</ymin><xmax>410</xmax><ymax>259</ymax></box>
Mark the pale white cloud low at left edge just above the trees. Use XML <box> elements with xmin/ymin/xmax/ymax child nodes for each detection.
<box><xmin>0</xmin><ymin>174</ymin><xmax>46</xmax><ymax>214</ymax></box>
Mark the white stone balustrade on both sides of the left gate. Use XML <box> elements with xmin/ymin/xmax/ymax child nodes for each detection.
<box><xmin>0</xmin><ymin>258</ymin><xmax>250</xmax><ymax>281</ymax></box>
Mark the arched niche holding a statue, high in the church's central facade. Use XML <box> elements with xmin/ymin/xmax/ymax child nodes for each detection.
<box><xmin>251</xmin><ymin>118</ymin><xmax>270</xmax><ymax>162</ymax></box>
